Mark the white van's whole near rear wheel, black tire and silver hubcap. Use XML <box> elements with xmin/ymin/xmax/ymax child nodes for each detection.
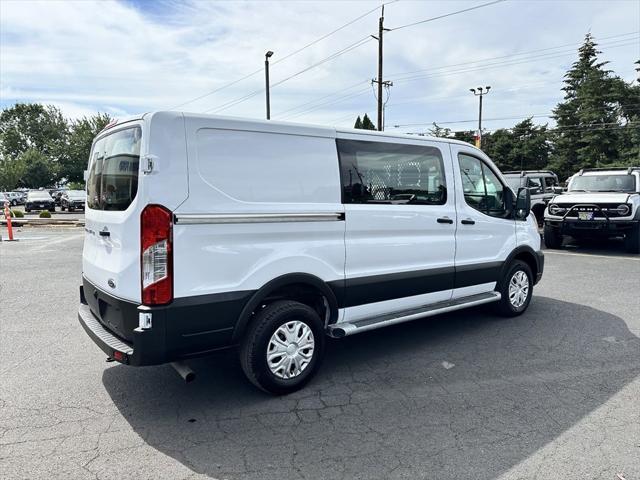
<box><xmin>240</xmin><ymin>300</ymin><xmax>325</xmax><ymax>395</ymax></box>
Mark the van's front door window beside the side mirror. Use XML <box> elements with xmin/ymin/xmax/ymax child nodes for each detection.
<box><xmin>458</xmin><ymin>154</ymin><xmax>507</xmax><ymax>217</ymax></box>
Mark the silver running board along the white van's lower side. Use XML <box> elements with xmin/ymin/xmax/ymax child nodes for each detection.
<box><xmin>327</xmin><ymin>292</ymin><xmax>502</xmax><ymax>338</ymax></box>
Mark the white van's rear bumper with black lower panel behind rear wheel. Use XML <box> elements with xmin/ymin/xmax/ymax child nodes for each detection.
<box><xmin>78</xmin><ymin>278</ymin><xmax>248</xmax><ymax>366</ymax></box>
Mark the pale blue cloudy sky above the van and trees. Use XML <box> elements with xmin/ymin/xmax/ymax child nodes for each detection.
<box><xmin>0</xmin><ymin>0</ymin><xmax>640</xmax><ymax>132</ymax></box>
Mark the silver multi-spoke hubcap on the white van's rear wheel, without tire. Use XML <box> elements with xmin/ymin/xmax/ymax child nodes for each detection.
<box><xmin>267</xmin><ymin>320</ymin><xmax>315</xmax><ymax>379</ymax></box>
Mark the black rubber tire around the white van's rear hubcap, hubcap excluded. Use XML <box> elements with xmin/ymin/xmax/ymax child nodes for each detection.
<box><xmin>240</xmin><ymin>300</ymin><xmax>325</xmax><ymax>395</ymax></box>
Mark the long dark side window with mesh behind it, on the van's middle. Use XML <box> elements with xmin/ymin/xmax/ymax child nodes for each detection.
<box><xmin>337</xmin><ymin>139</ymin><xmax>447</xmax><ymax>205</ymax></box>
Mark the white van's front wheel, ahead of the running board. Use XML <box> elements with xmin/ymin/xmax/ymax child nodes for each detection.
<box><xmin>497</xmin><ymin>260</ymin><xmax>533</xmax><ymax>317</ymax></box>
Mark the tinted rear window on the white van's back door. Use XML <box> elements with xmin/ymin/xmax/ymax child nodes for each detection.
<box><xmin>87</xmin><ymin>126</ymin><xmax>142</xmax><ymax>210</ymax></box>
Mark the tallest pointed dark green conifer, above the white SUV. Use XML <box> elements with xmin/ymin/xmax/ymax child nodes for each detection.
<box><xmin>551</xmin><ymin>33</ymin><xmax>622</xmax><ymax>177</ymax></box>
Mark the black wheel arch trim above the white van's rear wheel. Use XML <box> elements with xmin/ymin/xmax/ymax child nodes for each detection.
<box><xmin>232</xmin><ymin>273</ymin><xmax>338</xmax><ymax>342</ymax></box>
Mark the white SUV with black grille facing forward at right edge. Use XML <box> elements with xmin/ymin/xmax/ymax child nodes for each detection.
<box><xmin>544</xmin><ymin>167</ymin><xmax>640</xmax><ymax>253</ymax></box>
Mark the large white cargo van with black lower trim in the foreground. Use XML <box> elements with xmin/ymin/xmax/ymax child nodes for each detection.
<box><xmin>79</xmin><ymin>112</ymin><xmax>544</xmax><ymax>394</ymax></box>
